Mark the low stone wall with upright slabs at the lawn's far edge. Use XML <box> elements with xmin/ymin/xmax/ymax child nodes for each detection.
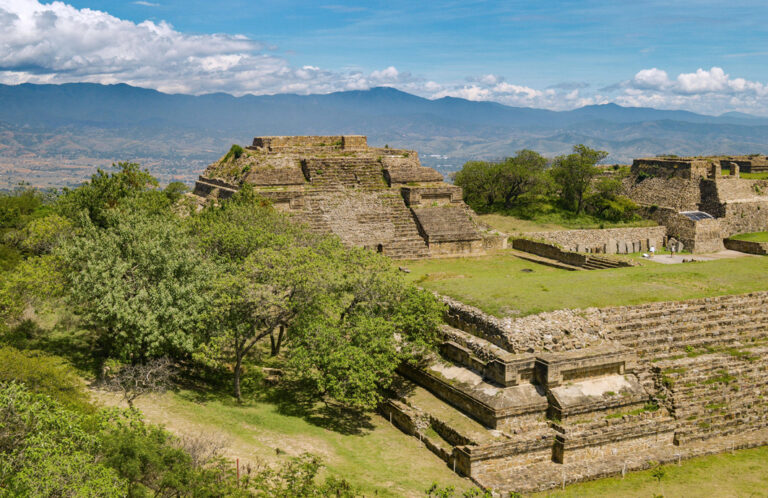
<box><xmin>525</xmin><ymin>226</ymin><xmax>667</xmax><ymax>254</ymax></box>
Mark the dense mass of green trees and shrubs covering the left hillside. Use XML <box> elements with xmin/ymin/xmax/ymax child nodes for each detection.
<box><xmin>0</xmin><ymin>163</ymin><xmax>480</xmax><ymax>496</ymax></box>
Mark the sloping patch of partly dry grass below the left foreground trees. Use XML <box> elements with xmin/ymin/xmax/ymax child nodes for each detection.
<box><xmin>95</xmin><ymin>391</ymin><xmax>473</xmax><ymax>497</ymax></box>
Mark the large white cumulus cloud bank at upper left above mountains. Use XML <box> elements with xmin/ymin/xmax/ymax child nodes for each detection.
<box><xmin>0</xmin><ymin>0</ymin><xmax>420</xmax><ymax>95</ymax></box>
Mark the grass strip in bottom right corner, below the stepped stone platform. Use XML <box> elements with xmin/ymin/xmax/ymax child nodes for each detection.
<box><xmin>534</xmin><ymin>446</ymin><xmax>768</xmax><ymax>498</ymax></box>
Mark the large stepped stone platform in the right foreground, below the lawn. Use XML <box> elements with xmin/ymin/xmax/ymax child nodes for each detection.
<box><xmin>383</xmin><ymin>292</ymin><xmax>768</xmax><ymax>496</ymax></box>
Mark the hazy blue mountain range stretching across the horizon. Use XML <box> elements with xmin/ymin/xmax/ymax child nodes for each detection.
<box><xmin>0</xmin><ymin>83</ymin><xmax>768</xmax><ymax>188</ymax></box>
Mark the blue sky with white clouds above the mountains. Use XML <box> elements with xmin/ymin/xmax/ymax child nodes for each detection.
<box><xmin>0</xmin><ymin>0</ymin><xmax>768</xmax><ymax>115</ymax></box>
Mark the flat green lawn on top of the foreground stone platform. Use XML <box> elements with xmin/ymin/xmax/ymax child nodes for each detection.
<box><xmin>408</xmin><ymin>251</ymin><xmax>768</xmax><ymax>316</ymax></box>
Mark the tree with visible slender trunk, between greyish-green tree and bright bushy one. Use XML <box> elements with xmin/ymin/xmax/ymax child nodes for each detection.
<box><xmin>191</xmin><ymin>188</ymin><xmax>330</xmax><ymax>400</ymax></box>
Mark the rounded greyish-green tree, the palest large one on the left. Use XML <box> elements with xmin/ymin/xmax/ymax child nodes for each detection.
<box><xmin>62</xmin><ymin>211</ymin><xmax>209</xmax><ymax>370</ymax></box>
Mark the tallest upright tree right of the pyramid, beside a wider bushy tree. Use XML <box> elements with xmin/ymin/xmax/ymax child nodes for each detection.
<box><xmin>550</xmin><ymin>144</ymin><xmax>608</xmax><ymax>214</ymax></box>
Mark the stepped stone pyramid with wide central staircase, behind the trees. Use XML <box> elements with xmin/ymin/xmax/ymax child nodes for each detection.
<box><xmin>194</xmin><ymin>135</ymin><xmax>484</xmax><ymax>259</ymax></box>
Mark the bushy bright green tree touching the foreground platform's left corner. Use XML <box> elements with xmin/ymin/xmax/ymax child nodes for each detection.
<box><xmin>288</xmin><ymin>249</ymin><xmax>442</xmax><ymax>410</ymax></box>
